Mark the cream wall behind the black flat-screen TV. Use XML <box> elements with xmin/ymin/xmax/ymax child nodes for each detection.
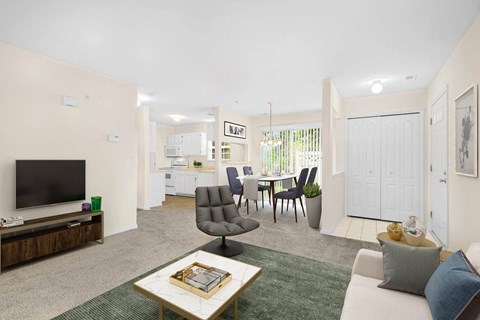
<box><xmin>0</xmin><ymin>43</ymin><xmax>137</xmax><ymax>235</ymax></box>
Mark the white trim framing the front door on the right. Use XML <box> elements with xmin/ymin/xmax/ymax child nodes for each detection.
<box><xmin>425</xmin><ymin>84</ymin><xmax>450</xmax><ymax>247</ymax></box>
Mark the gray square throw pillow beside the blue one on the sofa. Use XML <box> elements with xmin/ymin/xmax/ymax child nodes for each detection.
<box><xmin>378</xmin><ymin>239</ymin><xmax>441</xmax><ymax>295</ymax></box>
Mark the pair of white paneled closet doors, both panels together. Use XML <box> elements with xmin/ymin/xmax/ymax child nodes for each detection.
<box><xmin>346</xmin><ymin>113</ymin><xmax>423</xmax><ymax>221</ymax></box>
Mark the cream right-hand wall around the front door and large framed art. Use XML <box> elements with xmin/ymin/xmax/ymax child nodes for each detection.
<box><xmin>427</xmin><ymin>17</ymin><xmax>480</xmax><ymax>250</ymax></box>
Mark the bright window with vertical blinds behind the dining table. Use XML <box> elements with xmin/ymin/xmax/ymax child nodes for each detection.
<box><xmin>262</xmin><ymin>127</ymin><xmax>322</xmax><ymax>182</ymax></box>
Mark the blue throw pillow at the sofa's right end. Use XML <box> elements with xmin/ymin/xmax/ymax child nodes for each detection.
<box><xmin>425</xmin><ymin>251</ymin><xmax>480</xmax><ymax>320</ymax></box>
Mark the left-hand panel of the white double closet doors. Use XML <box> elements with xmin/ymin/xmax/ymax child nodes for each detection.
<box><xmin>347</xmin><ymin>117</ymin><xmax>381</xmax><ymax>219</ymax></box>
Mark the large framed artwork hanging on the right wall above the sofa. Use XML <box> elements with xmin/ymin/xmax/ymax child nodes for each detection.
<box><xmin>455</xmin><ymin>84</ymin><xmax>478</xmax><ymax>177</ymax></box>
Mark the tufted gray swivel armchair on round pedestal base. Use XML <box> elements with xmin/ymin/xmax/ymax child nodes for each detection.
<box><xmin>195</xmin><ymin>186</ymin><xmax>260</xmax><ymax>257</ymax></box>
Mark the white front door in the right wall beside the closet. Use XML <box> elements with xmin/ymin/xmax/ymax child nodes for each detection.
<box><xmin>430</xmin><ymin>90</ymin><xmax>448</xmax><ymax>246</ymax></box>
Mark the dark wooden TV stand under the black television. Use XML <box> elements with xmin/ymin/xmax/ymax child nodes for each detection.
<box><xmin>0</xmin><ymin>211</ymin><xmax>103</xmax><ymax>272</ymax></box>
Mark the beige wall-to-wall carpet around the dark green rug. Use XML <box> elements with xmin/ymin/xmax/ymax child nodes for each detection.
<box><xmin>0</xmin><ymin>197</ymin><xmax>379</xmax><ymax>320</ymax></box>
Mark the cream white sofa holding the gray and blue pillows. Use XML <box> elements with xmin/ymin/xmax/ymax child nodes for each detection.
<box><xmin>341</xmin><ymin>243</ymin><xmax>480</xmax><ymax>320</ymax></box>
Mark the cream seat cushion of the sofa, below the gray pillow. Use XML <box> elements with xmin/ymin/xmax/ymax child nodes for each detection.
<box><xmin>341</xmin><ymin>274</ymin><xmax>432</xmax><ymax>320</ymax></box>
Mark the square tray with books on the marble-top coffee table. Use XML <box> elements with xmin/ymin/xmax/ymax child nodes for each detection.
<box><xmin>169</xmin><ymin>262</ymin><xmax>232</xmax><ymax>299</ymax></box>
